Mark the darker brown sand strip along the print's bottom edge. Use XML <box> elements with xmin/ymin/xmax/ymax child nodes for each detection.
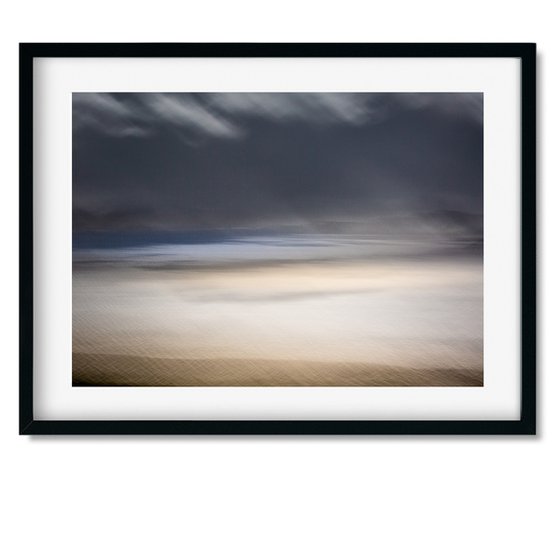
<box><xmin>72</xmin><ymin>353</ymin><xmax>483</xmax><ymax>387</ymax></box>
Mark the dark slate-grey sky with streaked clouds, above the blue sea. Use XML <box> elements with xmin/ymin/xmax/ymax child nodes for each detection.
<box><xmin>73</xmin><ymin>93</ymin><xmax>483</xmax><ymax>232</ymax></box>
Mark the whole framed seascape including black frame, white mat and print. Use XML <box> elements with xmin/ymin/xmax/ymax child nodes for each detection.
<box><xmin>20</xmin><ymin>43</ymin><xmax>536</xmax><ymax>435</ymax></box>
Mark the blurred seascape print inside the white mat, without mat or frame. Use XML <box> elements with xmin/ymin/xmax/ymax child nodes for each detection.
<box><xmin>72</xmin><ymin>92</ymin><xmax>484</xmax><ymax>387</ymax></box>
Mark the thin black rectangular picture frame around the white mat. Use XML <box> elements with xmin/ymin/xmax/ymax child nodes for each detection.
<box><xmin>19</xmin><ymin>43</ymin><xmax>536</xmax><ymax>435</ymax></box>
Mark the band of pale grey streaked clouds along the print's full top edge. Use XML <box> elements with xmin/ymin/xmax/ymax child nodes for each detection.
<box><xmin>73</xmin><ymin>92</ymin><xmax>482</xmax><ymax>138</ymax></box>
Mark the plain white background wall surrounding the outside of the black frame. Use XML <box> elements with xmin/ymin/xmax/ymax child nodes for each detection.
<box><xmin>0</xmin><ymin>0</ymin><xmax>560</xmax><ymax>560</ymax></box>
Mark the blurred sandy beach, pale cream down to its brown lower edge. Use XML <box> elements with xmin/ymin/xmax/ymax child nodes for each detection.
<box><xmin>73</xmin><ymin>253</ymin><xmax>482</xmax><ymax>386</ymax></box>
